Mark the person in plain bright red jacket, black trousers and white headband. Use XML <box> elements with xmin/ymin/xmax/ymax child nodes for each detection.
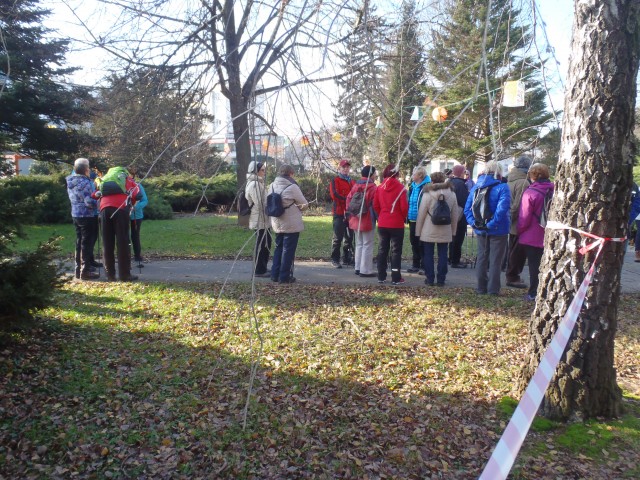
<box><xmin>373</xmin><ymin>165</ymin><xmax>409</xmax><ymax>285</ymax></box>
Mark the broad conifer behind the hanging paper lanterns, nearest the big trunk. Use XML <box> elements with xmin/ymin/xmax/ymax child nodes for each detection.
<box><xmin>418</xmin><ymin>0</ymin><xmax>551</xmax><ymax>172</ymax></box>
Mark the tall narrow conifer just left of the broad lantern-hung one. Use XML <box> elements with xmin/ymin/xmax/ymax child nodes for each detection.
<box><xmin>382</xmin><ymin>0</ymin><xmax>425</xmax><ymax>172</ymax></box>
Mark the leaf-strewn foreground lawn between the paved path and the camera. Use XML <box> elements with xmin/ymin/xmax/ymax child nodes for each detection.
<box><xmin>0</xmin><ymin>282</ymin><xmax>640</xmax><ymax>479</ymax></box>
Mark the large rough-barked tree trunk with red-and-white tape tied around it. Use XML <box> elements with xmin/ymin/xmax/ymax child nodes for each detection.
<box><xmin>519</xmin><ymin>0</ymin><xmax>640</xmax><ymax>419</ymax></box>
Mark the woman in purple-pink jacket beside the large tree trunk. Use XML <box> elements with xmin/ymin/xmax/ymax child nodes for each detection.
<box><xmin>518</xmin><ymin>163</ymin><xmax>553</xmax><ymax>301</ymax></box>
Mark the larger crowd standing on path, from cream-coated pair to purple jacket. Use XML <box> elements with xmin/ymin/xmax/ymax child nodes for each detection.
<box><xmin>245</xmin><ymin>156</ymin><xmax>553</xmax><ymax>300</ymax></box>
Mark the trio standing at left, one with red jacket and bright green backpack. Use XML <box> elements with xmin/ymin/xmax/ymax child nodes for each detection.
<box><xmin>66</xmin><ymin>158</ymin><xmax>148</xmax><ymax>282</ymax></box>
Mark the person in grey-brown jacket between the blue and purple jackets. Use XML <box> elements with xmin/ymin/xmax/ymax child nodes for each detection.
<box><xmin>505</xmin><ymin>155</ymin><xmax>533</xmax><ymax>288</ymax></box>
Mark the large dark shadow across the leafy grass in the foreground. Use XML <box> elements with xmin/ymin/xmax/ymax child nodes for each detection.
<box><xmin>0</xmin><ymin>299</ymin><xmax>499</xmax><ymax>479</ymax></box>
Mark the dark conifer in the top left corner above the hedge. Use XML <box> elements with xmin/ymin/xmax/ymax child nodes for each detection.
<box><xmin>0</xmin><ymin>0</ymin><xmax>91</xmax><ymax>160</ymax></box>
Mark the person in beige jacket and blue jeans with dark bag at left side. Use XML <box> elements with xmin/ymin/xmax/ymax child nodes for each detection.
<box><xmin>267</xmin><ymin>164</ymin><xmax>309</xmax><ymax>283</ymax></box>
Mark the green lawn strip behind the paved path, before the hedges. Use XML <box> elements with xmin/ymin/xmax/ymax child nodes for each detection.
<box><xmin>19</xmin><ymin>215</ymin><xmax>475</xmax><ymax>260</ymax></box>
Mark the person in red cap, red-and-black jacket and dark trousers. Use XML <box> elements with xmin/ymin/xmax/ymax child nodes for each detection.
<box><xmin>329</xmin><ymin>160</ymin><xmax>356</xmax><ymax>268</ymax></box>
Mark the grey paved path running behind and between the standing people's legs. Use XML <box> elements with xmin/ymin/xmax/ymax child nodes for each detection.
<box><xmin>87</xmin><ymin>249</ymin><xmax>640</xmax><ymax>293</ymax></box>
